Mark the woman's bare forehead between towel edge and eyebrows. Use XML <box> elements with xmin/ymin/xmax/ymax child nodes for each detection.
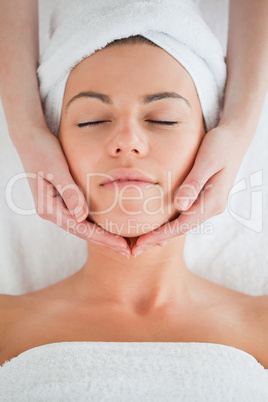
<box><xmin>61</xmin><ymin>44</ymin><xmax>200</xmax><ymax>109</ymax></box>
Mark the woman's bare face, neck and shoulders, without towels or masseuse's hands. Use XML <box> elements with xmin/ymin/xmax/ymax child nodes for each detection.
<box><xmin>0</xmin><ymin>37</ymin><xmax>268</xmax><ymax>368</ymax></box>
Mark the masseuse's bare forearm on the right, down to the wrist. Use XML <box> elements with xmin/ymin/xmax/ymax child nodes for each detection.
<box><xmin>221</xmin><ymin>0</ymin><xmax>268</xmax><ymax>135</ymax></box>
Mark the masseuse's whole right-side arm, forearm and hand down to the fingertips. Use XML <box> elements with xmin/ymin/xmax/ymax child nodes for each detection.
<box><xmin>132</xmin><ymin>0</ymin><xmax>268</xmax><ymax>255</ymax></box>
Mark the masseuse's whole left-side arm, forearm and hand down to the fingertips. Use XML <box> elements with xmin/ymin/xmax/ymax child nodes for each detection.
<box><xmin>0</xmin><ymin>0</ymin><xmax>130</xmax><ymax>254</ymax></box>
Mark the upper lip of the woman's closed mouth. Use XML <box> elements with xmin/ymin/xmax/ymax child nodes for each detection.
<box><xmin>101</xmin><ymin>169</ymin><xmax>157</xmax><ymax>186</ymax></box>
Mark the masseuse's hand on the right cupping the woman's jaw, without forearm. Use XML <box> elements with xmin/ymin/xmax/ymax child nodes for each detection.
<box><xmin>132</xmin><ymin>124</ymin><xmax>252</xmax><ymax>255</ymax></box>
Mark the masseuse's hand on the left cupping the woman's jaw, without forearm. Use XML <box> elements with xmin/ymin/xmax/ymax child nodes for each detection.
<box><xmin>19</xmin><ymin>128</ymin><xmax>130</xmax><ymax>254</ymax></box>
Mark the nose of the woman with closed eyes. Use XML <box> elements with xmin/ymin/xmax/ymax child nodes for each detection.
<box><xmin>108</xmin><ymin>122</ymin><xmax>149</xmax><ymax>157</ymax></box>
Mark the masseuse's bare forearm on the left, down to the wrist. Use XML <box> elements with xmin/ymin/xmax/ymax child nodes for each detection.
<box><xmin>0</xmin><ymin>0</ymin><xmax>46</xmax><ymax>149</ymax></box>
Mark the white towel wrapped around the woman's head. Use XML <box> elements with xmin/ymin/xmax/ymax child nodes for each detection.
<box><xmin>37</xmin><ymin>0</ymin><xmax>226</xmax><ymax>135</ymax></box>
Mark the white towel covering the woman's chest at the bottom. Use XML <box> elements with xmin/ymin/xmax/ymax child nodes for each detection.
<box><xmin>0</xmin><ymin>342</ymin><xmax>268</xmax><ymax>402</ymax></box>
